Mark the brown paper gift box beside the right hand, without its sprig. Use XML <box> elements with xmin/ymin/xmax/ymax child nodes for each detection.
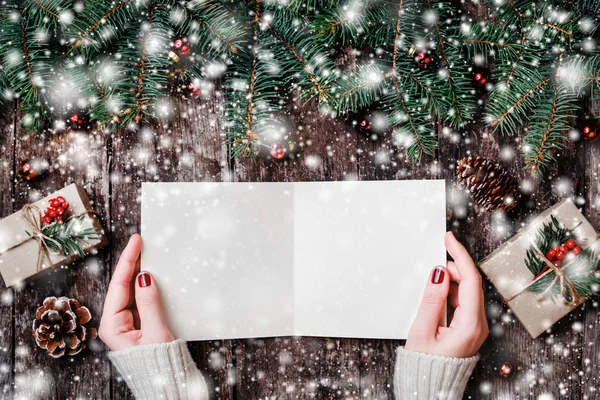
<box><xmin>479</xmin><ymin>199</ymin><xmax>600</xmax><ymax>338</ymax></box>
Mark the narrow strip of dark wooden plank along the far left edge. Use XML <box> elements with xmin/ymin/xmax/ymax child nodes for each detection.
<box><xmin>0</xmin><ymin>103</ymin><xmax>15</xmax><ymax>398</ymax></box>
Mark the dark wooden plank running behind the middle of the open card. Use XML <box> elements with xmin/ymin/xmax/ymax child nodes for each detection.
<box><xmin>235</xmin><ymin>95</ymin><xmax>360</xmax><ymax>399</ymax></box>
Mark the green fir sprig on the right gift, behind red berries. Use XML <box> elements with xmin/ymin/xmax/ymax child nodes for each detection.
<box><xmin>525</xmin><ymin>215</ymin><xmax>600</xmax><ymax>302</ymax></box>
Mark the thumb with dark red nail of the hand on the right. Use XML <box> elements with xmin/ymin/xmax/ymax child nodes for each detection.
<box><xmin>409</xmin><ymin>265</ymin><xmax>450</xmax><ymax>338</ymax></box>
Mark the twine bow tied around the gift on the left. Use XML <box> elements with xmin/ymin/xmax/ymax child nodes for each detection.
<box><xmin>2</xmin><ymin>204</ymin><xmax>94</xmax><ymax>272</ymax></box>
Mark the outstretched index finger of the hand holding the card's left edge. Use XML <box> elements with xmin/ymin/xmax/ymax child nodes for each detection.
<box><xmin>104</xmin><ymin>234</ymin><xmax>142</xmax><ymax>314</ymax></box>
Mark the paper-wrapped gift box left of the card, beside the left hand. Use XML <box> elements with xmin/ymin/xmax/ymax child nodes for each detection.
<box><xmin>0</xmin><ymin>184</ymin><xmax>108</xmax><ymax>287</ymax></box>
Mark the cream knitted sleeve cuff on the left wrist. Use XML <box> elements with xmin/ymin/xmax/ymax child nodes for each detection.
<box><xmin>108</xmin><ymin>340</ymin><xmax>208</xmax><ymax>400</ymax></box>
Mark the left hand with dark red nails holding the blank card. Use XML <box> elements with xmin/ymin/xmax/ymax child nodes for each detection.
<box><xmin>98</xmin><ymin>234</ymin><xmax>175</xmax><ymax>351</ymax></box>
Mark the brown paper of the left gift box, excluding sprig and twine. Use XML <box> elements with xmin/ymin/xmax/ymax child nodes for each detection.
<box><xmin>0</xmin><ymin>184</ymin><xmax>108</xmax><ymax>287</ymax></box>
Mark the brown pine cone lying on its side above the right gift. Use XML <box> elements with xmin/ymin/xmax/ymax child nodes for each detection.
<box><xmin>456</xmin><ymin>156</ymin><xmax>521</xmax><ymax>211</ymax></box>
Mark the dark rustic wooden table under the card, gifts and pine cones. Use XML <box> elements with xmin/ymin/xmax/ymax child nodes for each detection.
<box><xmin>0</xmin><ymin>79</ymin><xmax>600</xmax><ymax>399</ymax></box>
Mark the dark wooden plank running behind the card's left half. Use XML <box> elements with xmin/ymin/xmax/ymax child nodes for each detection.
<box><xmin>111</xmin><ymin>96</ymin><xmax>233</xmax><ymax>399</ymax></box>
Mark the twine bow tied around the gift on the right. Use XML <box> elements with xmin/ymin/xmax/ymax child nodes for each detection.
<box><xmin>504</xmin><ymin>232</ymin><xmax>600</xmax><ymax>306</ymax></box>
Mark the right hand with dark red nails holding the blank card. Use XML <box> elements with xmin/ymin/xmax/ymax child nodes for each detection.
<box><xmin>404</xmin><ymin>232</ymin><xmax>489</xmax><ymax>358</ymax></box>
